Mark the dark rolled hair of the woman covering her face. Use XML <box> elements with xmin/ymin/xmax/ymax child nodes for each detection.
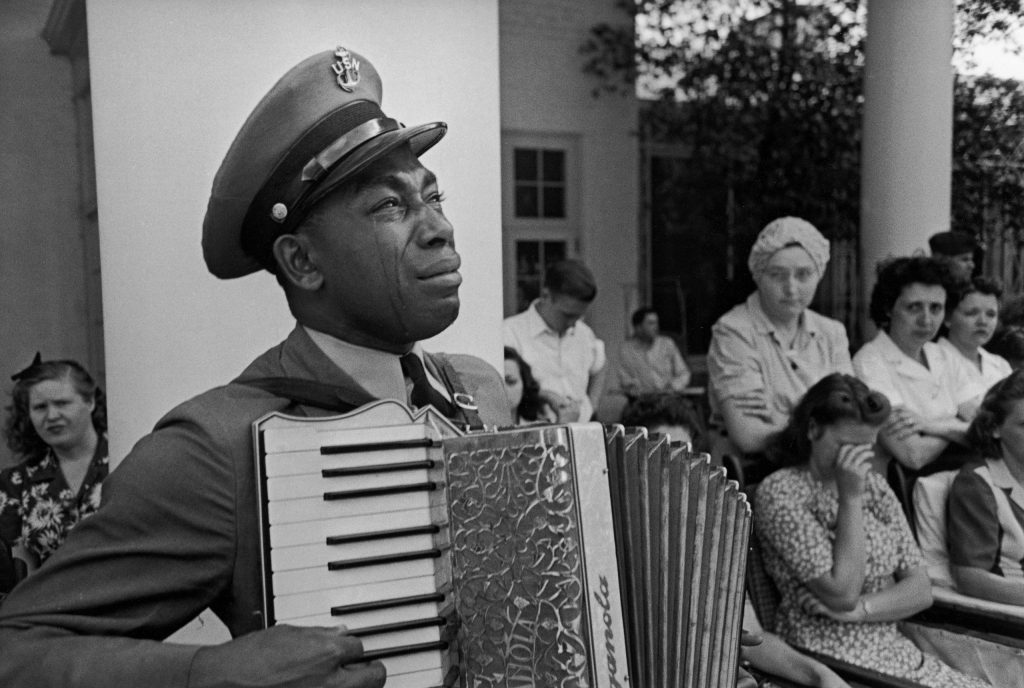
<box><xmin>772</xmin><ymin>373</ymin><xmax>892</xmax><ymax>466</ymax></box>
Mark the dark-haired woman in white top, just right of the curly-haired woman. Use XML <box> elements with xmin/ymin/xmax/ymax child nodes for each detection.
<box><xmin>939</xmin><ymin>277</ymin><xmax>1012</xmax><ymax>389</ymax></box>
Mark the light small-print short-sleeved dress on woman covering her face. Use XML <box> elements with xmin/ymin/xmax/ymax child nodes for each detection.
<box><xmin>754</xmin><ymin>467</ymin><xmax>988</xmax><ymax>688</ymax></box>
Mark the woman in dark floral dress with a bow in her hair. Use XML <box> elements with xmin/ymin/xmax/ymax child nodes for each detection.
<box><xmin>0</xmin><ymin>354</ymin><xmax>108</xmax><ymax>568</ymax></box>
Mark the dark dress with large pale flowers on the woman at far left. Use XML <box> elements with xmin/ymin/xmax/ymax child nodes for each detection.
<box><xmin>0</xmin><ymin>438</ymin><xmax>109</xmax><ymax>564</ymax></box>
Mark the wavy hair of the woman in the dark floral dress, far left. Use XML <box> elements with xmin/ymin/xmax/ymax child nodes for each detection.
<box><xmin>3</xmin><ymin>360</ymin><xmax>106</xmax><ymax>458</ymax></box>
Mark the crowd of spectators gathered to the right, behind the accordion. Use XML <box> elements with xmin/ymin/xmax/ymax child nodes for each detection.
<box><xmin>506</xmin><ymin>223</ymin><xmax>1024</xmax><ymax>686</ymax></box>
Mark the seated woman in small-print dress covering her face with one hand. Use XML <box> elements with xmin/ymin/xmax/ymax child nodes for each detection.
<box><xmin>754</xmin><ymin>374</ymin><xmax>988</xmax><ymax>688</ymax></box>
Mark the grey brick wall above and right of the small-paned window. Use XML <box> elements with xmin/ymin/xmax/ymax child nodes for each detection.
<box><xmin>501</xmin><ymin>0</ymin><xmax>640</xmax><ymax>420</ymax></box>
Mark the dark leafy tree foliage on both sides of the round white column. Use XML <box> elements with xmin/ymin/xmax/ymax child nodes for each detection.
<box><xmin>582</xmin><ymin>0</ymin><xmax>1024</xmax><ymax>272</ymax></box>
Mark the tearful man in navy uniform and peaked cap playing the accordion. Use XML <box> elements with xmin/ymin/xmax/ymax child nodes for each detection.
<box><xmin>0</xmin><ymin>48</ymin><xmax>511</xmax><ymax>688</ymax></box>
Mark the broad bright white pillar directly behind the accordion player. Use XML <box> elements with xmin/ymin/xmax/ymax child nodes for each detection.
<box><xmin>88</xmin><ymin>0</ymin><xmax>502</xmax><ymax>460</ymax></box>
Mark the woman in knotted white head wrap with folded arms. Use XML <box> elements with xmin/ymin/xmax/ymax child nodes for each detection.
<box><xmin>708</xmin><ymin>217</ymin><xmax>852</xmax><ymax>482</ymax></box>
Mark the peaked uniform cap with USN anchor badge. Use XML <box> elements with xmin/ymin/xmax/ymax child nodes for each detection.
<box><xmin>203</xmin><ymin>47</ymin><xmax>447</xmax><ymax>280</ymax></box>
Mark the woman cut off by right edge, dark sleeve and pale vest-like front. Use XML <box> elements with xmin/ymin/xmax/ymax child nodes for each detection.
<box><xmin>946</xmin><ymin>371</ymin><xmax>1024</xmax><ymax>605</ymax></box>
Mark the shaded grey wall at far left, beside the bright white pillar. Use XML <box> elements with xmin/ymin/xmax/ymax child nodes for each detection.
<box><xmin>0</xmin><ymin>0</ymin><xmax>90</xmax><ymax>468</ymax></box>
